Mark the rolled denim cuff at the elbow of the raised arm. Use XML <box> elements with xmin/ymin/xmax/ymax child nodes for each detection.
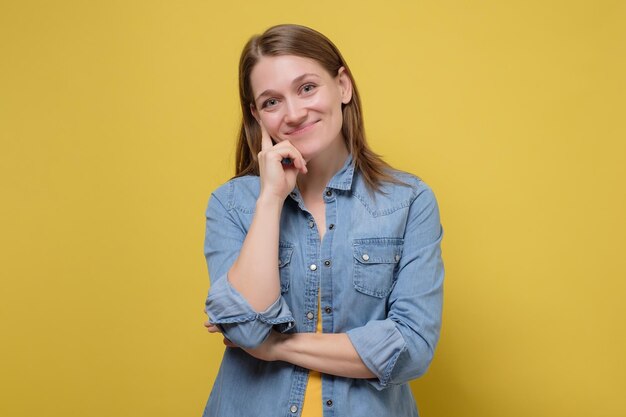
<box><xmin>205</xmin><ymin>275</ymin><xmax>295</xmax><ymax>349</ymax></box>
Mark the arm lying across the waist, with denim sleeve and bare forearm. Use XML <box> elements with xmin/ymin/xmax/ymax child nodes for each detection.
<box><xmin>209</xmin><ymin>182</ymin><xmax>444</xmax><ymax>390</ymax></box>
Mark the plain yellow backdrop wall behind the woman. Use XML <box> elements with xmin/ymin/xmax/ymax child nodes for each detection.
<box><xmin>0</xmin><ymin>0</ymin><xmax>626</xmax><ymax>417</ymax></box>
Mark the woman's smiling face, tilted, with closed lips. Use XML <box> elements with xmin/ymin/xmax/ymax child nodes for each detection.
<box><xmin>250</xmin><ymin>55</ymin><xmax>352</xmax><ymax>161</ymax></box>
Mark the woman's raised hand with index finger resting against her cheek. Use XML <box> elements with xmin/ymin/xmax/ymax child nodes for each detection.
<box><xmin>258</xmin><ymin>121</ymin><xmax>307</xmax><ymax>202</ymax></box>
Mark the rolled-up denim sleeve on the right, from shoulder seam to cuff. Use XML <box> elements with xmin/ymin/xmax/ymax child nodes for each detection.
<box><xmin>347</xmin><ymin>183</ymin><xmax>444</xmax><ymax>390</ymax></box>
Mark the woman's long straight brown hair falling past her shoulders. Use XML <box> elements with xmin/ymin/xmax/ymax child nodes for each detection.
<box><xmin>235</xmin><ymin>25</ymin><xmax>401</xmax><ymax>191</ymax></box>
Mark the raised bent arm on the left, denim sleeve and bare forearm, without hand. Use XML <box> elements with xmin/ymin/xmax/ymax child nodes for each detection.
<box><xmin>204</xmin><ymin>188</ymin><xmax>295</xmax><ymax>348</ymax></box>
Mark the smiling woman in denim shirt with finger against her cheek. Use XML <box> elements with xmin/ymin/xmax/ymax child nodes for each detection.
<box><xmin>204</xmin><ymin>25</ymin><xmax>443</xmax><ymax>417</ymax></box>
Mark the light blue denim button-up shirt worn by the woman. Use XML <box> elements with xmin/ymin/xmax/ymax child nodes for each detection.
<box><xmin>204</xmin><ymin>157</ymin><xmax>444</xmax><ymax>417</ymax></box>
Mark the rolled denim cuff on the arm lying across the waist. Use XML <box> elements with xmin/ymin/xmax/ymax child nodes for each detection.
<box><xmin>347</xmin><ymin>319</ymin><xmax>407</xmax><ymax>391</ymax></box>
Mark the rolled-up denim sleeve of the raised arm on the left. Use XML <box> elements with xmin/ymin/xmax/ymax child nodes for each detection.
<box><xmin>204</xmin><ymin>183</ymin><xmax>295</xmax><ymax>348</ymax></box>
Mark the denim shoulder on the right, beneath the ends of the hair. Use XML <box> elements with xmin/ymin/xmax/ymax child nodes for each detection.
<box><xmin>352</xmin><ymin>169</ymin><xmax>436</xmax><ymax>216</ymax></box>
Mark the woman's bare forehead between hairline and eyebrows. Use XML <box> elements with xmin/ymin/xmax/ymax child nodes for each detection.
<box><xmin>250</xmin><ymin>55</ymin><xmax>330</xmax><ymax>95</ymax></box>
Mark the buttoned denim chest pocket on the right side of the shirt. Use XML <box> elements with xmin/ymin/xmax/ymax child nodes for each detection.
<box><xmin>353</xmin><ymin>237</ymin><xmax>404</xmax><ymax>298</ymax></box>
